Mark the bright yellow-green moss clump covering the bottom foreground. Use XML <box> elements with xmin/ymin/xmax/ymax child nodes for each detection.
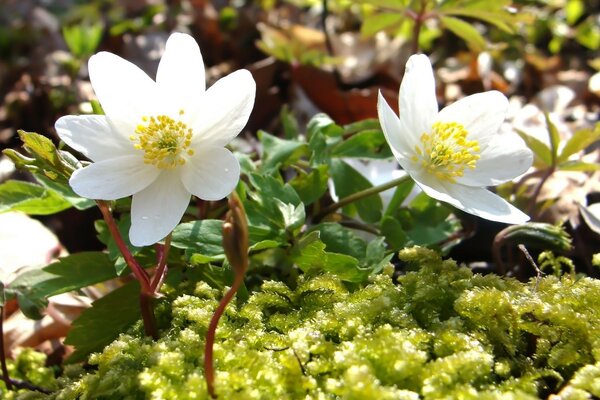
<box><xmin>18</xmin><ymin>248</ymin><xmax>600</xmax><ymax>399</ymax></box>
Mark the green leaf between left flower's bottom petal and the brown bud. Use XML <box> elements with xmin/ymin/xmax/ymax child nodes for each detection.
<box><xmin>171</xmin><ymin>219</ymin><xmax>225</xmax><ymax>263</ymax></box>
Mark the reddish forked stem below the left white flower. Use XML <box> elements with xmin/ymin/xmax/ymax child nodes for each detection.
<box><xmin>96</xmin><ymin>200</ymin><xmax>158</xmax><ymax>340</ymax></box>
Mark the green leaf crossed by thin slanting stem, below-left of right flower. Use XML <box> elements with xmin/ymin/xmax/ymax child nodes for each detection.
<box><xmin>331</xmin><ymin>159</ymin><xmax>383</xmax><ymax>222</ymax></box>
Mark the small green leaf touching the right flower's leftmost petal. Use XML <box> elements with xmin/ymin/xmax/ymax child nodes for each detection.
<box><xmin>331</xmin><ymin>129</ymin><xmax>393</xmax><ymax>158</ymax></box>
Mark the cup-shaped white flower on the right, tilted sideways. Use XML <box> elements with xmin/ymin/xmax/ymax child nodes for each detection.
<box><xmin>377</xmin><ymin>54</ymin><xmax>533</xmax><ymax>224</ymax></box>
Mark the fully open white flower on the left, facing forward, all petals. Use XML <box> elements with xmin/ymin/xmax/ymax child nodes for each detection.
<box><xmin>56</xmin><ymin>33</ymin><xmax>256</xmax><ymax>246</ymax></box>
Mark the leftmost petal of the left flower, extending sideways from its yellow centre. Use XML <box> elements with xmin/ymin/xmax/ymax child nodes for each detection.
<box><xmin>54</xmin><ymin>115</ymin><xmax>133</xmax><ymax>161</ymax></box>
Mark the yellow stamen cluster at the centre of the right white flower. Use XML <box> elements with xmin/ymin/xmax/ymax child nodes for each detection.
<box><xmin>412</xmin><ymin>122</ymin><xmax>479</xmax><ymax>183</ymax></box>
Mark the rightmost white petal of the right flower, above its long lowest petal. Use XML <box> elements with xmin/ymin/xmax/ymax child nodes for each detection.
<box><xmin>456</xmin><ymin>132</ymin><xmax>533</xmax><ymax>186</ymax></box>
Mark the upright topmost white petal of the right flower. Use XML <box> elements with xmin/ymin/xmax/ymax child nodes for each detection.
<box><xmin>399</xmin><ymin>54</ymin><xmax>438</xmax><ymax>140</ymax></box>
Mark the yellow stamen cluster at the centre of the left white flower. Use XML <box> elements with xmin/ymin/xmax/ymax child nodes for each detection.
<box><xmin>129</xmin><ymin>110</ymin><xmax>194</xmax><ymax>169</ymax></box>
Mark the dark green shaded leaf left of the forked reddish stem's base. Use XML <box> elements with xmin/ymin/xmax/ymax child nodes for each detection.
<box><xmin>65</xmin><ymin>281</ymin><xmax>140</xmax><ymax>363</ymax></box>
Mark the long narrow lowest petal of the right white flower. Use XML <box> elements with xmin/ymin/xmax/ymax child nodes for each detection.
<box><xmin>413</xmin><ymin>175</ymin><xmax>529</xmax><ymax>224</ymax></box>
